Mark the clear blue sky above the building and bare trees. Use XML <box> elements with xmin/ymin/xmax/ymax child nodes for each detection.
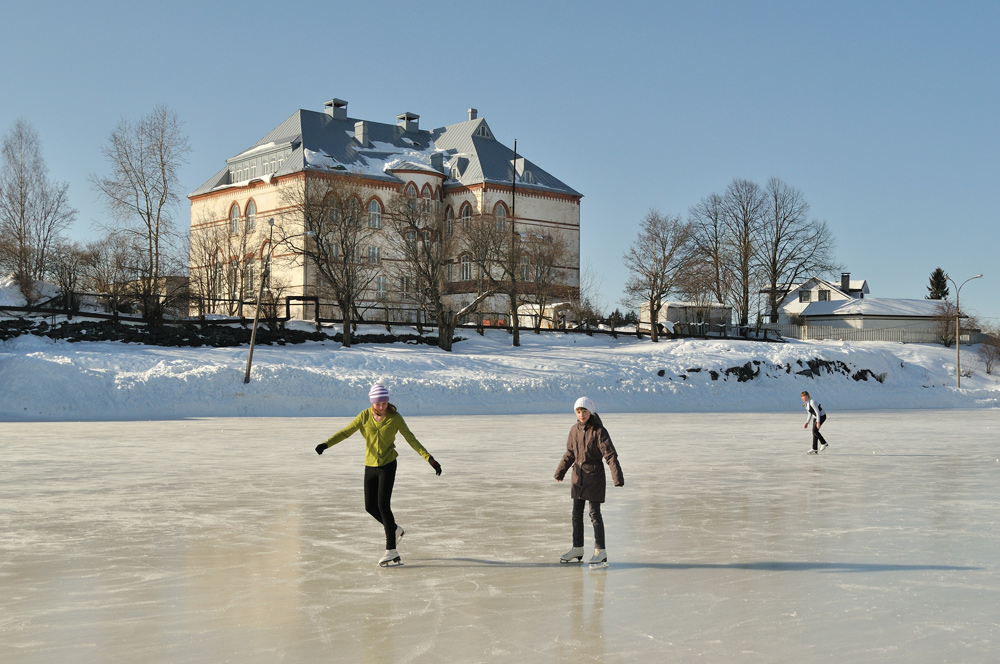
<box><xmin>0</xmin><ymin>0</ymin><xmax>1000</xmax><ymax>323</ymax></box>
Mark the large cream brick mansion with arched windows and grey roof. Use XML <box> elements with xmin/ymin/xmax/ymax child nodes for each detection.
<box><xmin>189</xmin><ymin>99</ymin><xmax>582</xmax><ymax>319</ymax></box>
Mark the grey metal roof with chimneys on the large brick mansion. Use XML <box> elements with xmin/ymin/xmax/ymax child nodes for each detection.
<box><xmin>190</xmin><ymin>99</ymin><xmax>581</xmax><ymax>196</ymax></box>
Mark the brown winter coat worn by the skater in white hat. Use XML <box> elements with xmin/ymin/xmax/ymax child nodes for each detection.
<box><xmin>556</xmin><ymin>413</ymin><xmax>625</xmax><ymax>503</ymax></box>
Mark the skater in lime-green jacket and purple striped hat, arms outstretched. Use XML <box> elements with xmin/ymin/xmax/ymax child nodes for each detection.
<box><xmin>316</xmin><ymin>383</ymin><xmax>441</xmax><ymax>567</ymax></box>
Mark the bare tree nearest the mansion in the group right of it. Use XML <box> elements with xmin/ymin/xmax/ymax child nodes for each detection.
<box><xmin>623</xmin><ymin>210</ymin><xmax>692</xmax><ymax>343</ymax></box>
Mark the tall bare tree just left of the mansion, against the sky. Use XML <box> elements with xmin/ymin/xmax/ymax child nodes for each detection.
<box><xmin>90</xmin><ymin>106</ymin><xmax>191</xmax><ymax>320</ymax></box>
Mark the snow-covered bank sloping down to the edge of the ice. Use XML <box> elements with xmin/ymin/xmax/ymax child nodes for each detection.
<box><xmin>0</xmin><ymin>328</ymin><xmax>1000</xmax><ymax>420</ymax></box>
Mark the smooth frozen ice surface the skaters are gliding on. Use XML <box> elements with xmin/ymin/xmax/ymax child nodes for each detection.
<box><xmin>0</xmin><ymin>408</ymin><xmax>1000</xmax><ymax>664</ymax></box>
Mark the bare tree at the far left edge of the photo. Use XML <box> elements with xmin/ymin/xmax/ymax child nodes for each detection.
<box><xmin>0</xmin><ymin>120</ymin><xmax>76</xmax><ymax>306</ymax></box>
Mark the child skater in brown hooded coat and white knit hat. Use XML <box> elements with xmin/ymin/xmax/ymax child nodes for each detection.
<box><xmin>555</xmin><ymin>397</ymin><xmax>625</xmax><ymax>565</ymax></box>
